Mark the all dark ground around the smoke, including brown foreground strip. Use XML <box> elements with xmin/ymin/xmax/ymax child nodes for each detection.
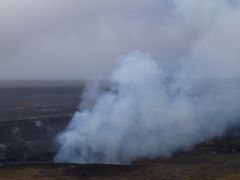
<box><xmin>0</xmin><ymin>82</ymin><xmax>240</xmax><ymax>179</ymax></box>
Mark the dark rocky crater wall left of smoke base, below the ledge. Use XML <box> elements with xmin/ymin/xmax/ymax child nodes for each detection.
<box><xmin>0</xmin><ymin>116</ymin><xmax>71</xmax><ymax>162</ymax></box>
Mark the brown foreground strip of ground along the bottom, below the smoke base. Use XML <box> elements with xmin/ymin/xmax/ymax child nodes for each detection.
<box><xmin>0</xmin><ymin>154</ymin><xmax>240</xmax><ymax>180</ymax></box>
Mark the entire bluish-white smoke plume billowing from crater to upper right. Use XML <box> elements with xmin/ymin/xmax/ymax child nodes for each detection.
<box><xmin>55</xmin><ymin>0</ymin><xmax>240</xmax><ymax>164</ymax></box>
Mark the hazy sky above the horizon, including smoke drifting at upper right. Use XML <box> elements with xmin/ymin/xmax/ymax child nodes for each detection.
<box><xmin>0</xmin><ymin>0</ymin><xmax>240</xmax><ymax>79</ymax></box>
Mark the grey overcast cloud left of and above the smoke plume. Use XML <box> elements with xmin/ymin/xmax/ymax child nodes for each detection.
<box><xmin>0</xmin><ymin>0</ymin><xmax>188</xmax><ymax>79</ymax></box>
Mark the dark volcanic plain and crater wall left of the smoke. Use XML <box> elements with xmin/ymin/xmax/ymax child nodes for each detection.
<box><xmin>0</xmin><ymin>83</ymin><xmax>84</xmax><ymax>162</ymax></box>
